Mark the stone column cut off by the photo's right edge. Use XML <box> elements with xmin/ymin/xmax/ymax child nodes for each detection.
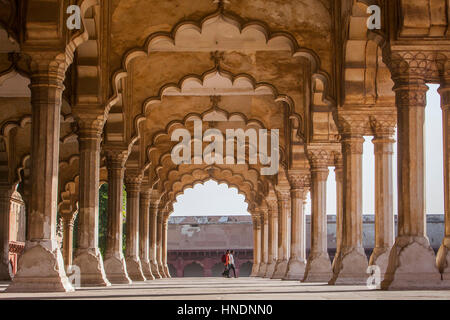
<box><xmin>436</xmin><ymin>79</ymin><xmax>450</xmax><ymax>286</ymax></box>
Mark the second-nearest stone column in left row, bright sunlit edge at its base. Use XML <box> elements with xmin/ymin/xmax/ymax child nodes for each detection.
<box><xmin>73</xmin><ymin>115</ymin><xmax>111</xmax><ymax>286</ymax></box>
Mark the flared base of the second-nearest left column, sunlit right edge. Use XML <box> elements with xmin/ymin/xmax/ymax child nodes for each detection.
<box><xmin>72</xmin><ymin>248</ymin><xmax>111</xmax><ymax>287</ymax></box>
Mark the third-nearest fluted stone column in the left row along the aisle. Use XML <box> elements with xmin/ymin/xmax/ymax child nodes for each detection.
<box><xmin>104</xmin><ymin>148</ymin><xmax>131</xmax><ymax>284</ymax></box>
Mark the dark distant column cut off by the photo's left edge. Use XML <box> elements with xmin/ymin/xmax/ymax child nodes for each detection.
<box><xmin>0</xmin><ymin>186</ymin><xmax>12</xmax><ymax>281</ymax></box>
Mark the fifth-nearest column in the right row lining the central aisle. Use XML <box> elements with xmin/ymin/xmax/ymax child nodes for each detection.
<box><xmin>272</xmin><ymin>188</ymin><xmax>291</xmax><ymax>279</ymax></box>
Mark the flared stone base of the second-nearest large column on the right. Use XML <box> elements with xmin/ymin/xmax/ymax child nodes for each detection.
<box><xmin>328</xmin><ymin>247</ymin><xmax>369</xmax><ymax>285</ymax></box>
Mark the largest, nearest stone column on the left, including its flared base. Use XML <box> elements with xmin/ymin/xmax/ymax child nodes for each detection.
<box><xmin>6</xmin><ymin>52</ymin><xmax>74</xmax><ymax>292</ymax></box>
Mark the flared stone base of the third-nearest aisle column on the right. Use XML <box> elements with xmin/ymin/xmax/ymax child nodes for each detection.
<box><xmin>302</xmin><ymin>252</ymin><xmax>333</xmax><ymax>282</ymax></box>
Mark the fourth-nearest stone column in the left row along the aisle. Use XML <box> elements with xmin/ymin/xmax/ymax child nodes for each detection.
<box><xmin>125</xmin><ymin>170</ymin><xmax>146</xmax><ymax>281</ymax></box>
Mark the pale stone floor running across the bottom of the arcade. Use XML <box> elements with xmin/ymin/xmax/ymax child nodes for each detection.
<box><xmin>0</xmin><ymin>278</ymin><xmax>450</xmax><ymax>300</ymax></box>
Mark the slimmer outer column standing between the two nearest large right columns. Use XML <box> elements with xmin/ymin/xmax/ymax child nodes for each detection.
<box><xmin>369</xmin><ymin>118</ymin><xmax>396</xmax><ymax>279</ymax></box>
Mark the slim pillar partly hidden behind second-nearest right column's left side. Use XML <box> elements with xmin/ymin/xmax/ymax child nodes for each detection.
<box><xmin>331</xmin><ymin>154</ymin><xmax>344</xmax><ymax>273</ymax></box>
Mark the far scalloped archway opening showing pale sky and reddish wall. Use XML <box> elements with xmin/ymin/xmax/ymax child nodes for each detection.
<box><xmin>168</xmin><ymin>180</ymin><xmax>253</xmax><ymax>277</ymax></box>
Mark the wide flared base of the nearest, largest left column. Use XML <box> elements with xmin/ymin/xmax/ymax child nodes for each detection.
<box><xmin>6</xmin><ymin>240</ymin><xmax>75</xmax><ymax>292</ymax></box>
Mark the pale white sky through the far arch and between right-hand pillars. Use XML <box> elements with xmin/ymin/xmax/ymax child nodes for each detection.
<box><xmin>172</xmin><ymin>85</ymin><xmax>444</xmax><ymax>216</ymax></box>
